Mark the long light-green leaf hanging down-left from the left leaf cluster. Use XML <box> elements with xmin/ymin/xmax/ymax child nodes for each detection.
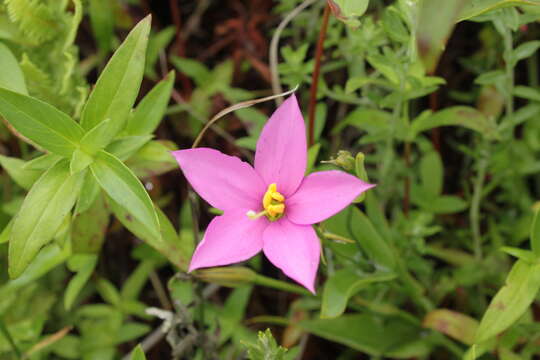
<box><xmin>9</xmin><ymin>160</ymin><xmax>84</xmax><ymax>278</ymax></box>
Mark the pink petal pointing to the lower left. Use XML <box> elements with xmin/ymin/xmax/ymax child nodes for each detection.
<box><xmin>189</xmin><ymin>210</ymin><xmax>268</xmax><ymax>272</ymax></box>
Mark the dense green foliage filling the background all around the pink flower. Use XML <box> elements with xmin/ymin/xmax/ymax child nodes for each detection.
<box><xmin>0</xmin><ymin>0</ymin><xmax>540</xmax><ymax>360</ymax></box>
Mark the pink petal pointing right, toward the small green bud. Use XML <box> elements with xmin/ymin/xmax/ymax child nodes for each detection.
<box><xmin>285</xmin><ymin>170</ymin><xmax>375</xmax><ymax>225</ymax></box>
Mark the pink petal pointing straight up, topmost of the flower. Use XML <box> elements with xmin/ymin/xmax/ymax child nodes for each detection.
<box><xmin>255</xmin><ymin>95</ymin><xmax>307</xmax><ymax>196</ymax></box>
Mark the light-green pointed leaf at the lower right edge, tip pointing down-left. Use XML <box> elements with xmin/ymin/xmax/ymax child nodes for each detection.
<box><xmin>475</xmin><ymin>260</ymin><xmax>540</xmax><ymax>344</ymax></box>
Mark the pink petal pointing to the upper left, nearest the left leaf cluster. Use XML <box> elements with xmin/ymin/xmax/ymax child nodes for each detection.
<box><xmin>172</xmin><ymin>148</ymin><xmax>266</xmax><ymax>211</ymax></box>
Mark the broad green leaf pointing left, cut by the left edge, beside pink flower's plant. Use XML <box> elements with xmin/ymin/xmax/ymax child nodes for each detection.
<box><xmin>0</xmin><ymin>88</ymin><xmax>84</xmax><ymax>157</ymax></box>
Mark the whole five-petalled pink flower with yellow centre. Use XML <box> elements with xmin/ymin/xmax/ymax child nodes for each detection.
<box><xmin>173</xmin><ymin>95</ymin><xmax>374</xmax><ymax>292</ymax></box>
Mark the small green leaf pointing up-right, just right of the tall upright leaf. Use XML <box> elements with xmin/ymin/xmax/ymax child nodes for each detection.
<box><xmin>126</xmin><ymin>71</ymin><xmax>175</xmax><ymax>136</ymax></box>
